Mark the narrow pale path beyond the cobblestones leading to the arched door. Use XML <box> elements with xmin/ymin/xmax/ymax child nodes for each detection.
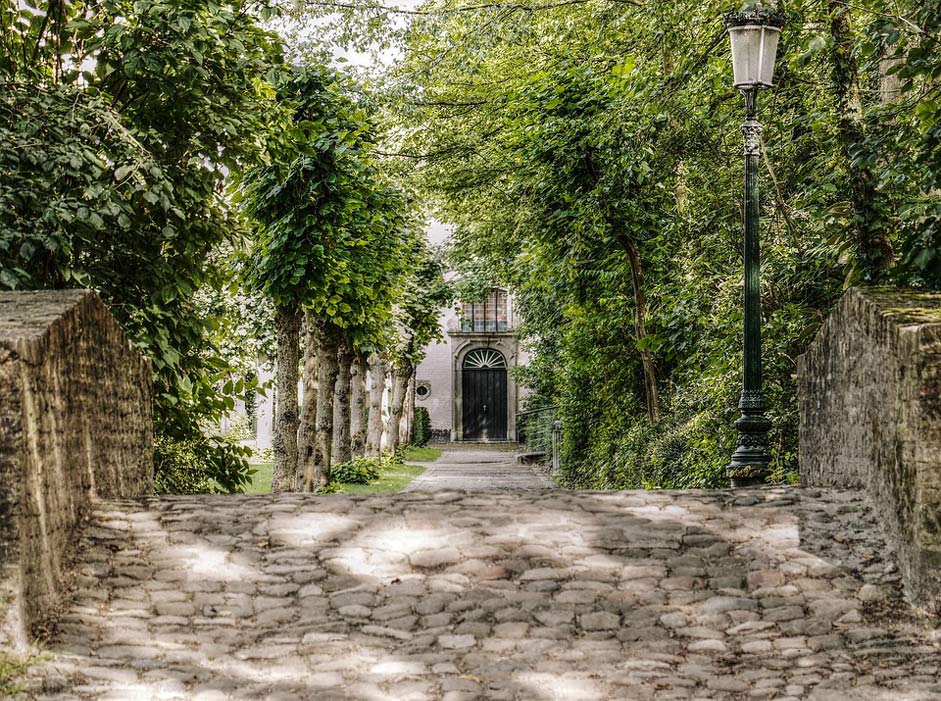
<box><xmin>405</xmin><ymin>450</ymin><xmax>555</xmax><ymax>492</ymax></box>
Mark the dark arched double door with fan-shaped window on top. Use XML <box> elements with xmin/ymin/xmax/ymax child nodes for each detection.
<box><xmin>461</xmin><ymin>348</ymin><xmax>507</xmax><ymax>441</ymax></box>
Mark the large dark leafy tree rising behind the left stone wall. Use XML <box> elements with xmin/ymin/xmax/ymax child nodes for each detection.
<box><xmin>0</xmin><ymin>0</ymin><xmax>281</xmax><ymax>491</ymax></box>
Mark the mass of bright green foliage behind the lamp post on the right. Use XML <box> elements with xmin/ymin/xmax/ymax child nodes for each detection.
<box><xmin>388</xmin><ymin>0</ymin><xmax>941</xmax><ymax>487</ymax></box>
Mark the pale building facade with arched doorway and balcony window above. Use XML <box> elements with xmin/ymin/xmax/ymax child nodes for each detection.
<box><xmin>415</xmin><ymin>288</ymin><xmax>526</xmax><ymax>441</ymax></box>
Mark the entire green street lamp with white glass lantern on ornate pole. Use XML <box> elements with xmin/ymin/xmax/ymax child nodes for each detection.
<box><xmin>725</xmin><ymin>5</ymin><xmax>784</xmax><ymax>487</ymax></box>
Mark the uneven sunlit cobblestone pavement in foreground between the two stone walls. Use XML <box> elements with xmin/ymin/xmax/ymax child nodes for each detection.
<box><xmin>29</xmin><ymin>489</ymin><xmax>941</xmax><ymax>701</ymax></box>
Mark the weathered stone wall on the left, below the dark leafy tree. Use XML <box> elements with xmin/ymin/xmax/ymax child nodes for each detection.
<box><xmin>0</xmin><ymin>290</ymin><xmax>153</xmax><ymax>647</ymax></box>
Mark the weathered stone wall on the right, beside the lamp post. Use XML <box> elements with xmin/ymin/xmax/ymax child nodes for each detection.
<box><xmin>798</xmin><ymin>288</ymin><xmax>941</xmax><ymax>601</ymax></box>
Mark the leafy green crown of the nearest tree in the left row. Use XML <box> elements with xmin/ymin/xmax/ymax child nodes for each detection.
<box><xmin>236</xmin><ymin>66</ymin><xmax>413</xmax><ymax>343</ymax></box>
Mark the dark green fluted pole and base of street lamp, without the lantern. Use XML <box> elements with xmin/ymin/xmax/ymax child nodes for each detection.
<box><xmin>729</xmin><ymin>86</ymin><xmax>771</xmax><ymax>487</ymax></box>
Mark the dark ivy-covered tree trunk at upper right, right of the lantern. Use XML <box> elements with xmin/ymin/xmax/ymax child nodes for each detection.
<box><xmin>829</xmin><ymin>0</ymin><xmax>894</xmax><ymax>284</ymax></box>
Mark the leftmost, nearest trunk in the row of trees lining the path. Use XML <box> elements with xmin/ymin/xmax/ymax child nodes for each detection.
<box><xmin>271</xmin><ymin>307</ymin><xmax>301</xmax><ymax>493</ymax></box>
